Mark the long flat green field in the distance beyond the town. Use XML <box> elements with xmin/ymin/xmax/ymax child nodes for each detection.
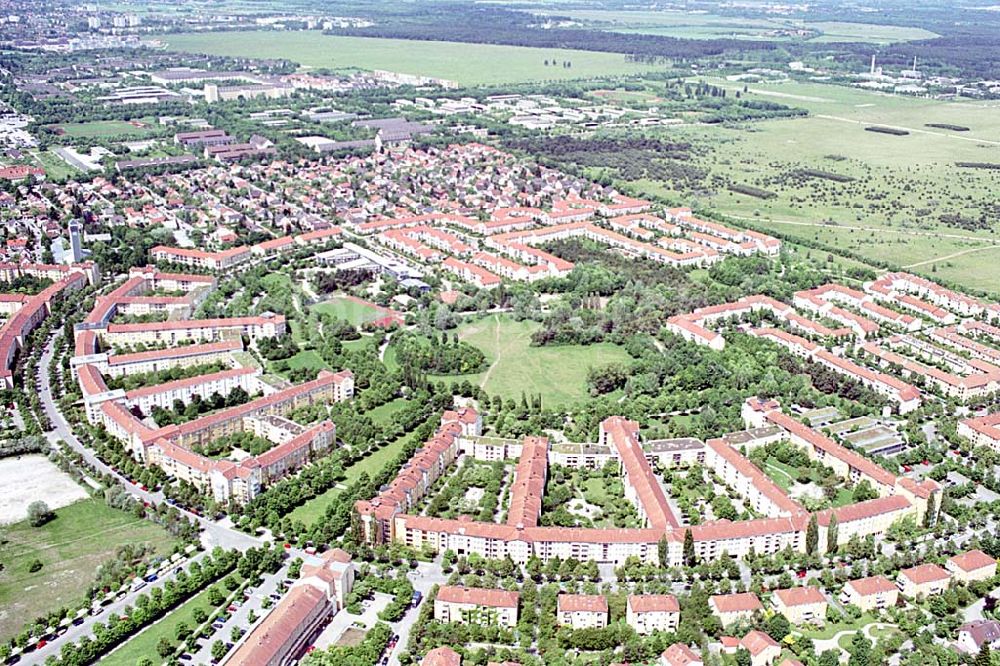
<box><xmin>162</xmin><ymin>31</ymin><xmax>659</xmax><ymax>85</ymax></box>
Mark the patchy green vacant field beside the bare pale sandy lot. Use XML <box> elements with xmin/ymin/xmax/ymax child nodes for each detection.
<box><xmin>0</xmin><ymin>499</ymin><xmax>174</xmax><ymax>640</ymax></box>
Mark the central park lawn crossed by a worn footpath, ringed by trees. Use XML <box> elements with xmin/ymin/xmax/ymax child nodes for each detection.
<box><xmin>424</xmin><ymin>315</ymin><xmax>628</xmax><ymax>407</ymax></box>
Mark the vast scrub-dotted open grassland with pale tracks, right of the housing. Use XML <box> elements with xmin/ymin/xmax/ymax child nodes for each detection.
<box><xmin>632</xmin><ymin>79</ymin><xmax>1000</xmax><ymax>292</ymax></box>
